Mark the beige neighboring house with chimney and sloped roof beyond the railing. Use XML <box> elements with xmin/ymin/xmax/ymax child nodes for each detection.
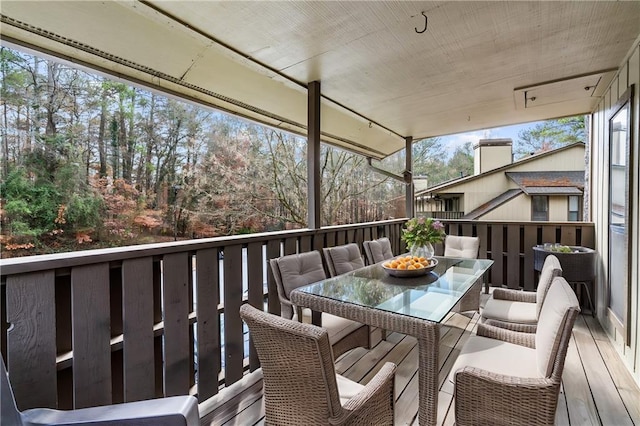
<box><xmin>415</xmin><ymin>139</ymin><xmax>585</xmax><ymax>222</ymax></box>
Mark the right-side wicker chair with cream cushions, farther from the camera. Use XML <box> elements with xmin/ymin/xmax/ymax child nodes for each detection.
<box><xmin>480</xmin><ymin>255</ymin><xmax>562</xmax><ymax>332</ymax></box>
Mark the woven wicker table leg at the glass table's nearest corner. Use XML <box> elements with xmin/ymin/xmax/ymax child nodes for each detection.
<box><xmin>416</xmin><ymin>322</ymin><xmax>440</xmax><ymax>426</ymax></box>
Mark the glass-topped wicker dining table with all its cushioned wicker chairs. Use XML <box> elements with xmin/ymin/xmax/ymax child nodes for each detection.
<box><xmin>255</xmin><ymin>237</ymin><xmax>580</xmax><ymax>425</ymax></box>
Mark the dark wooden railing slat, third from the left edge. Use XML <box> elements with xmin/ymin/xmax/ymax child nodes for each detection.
<box><xmin>122</xmin><ymin>257</ymin><xmax>155</xmax><ymax>402</ymax></box>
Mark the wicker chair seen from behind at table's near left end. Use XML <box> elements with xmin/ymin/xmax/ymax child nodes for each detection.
<box><xmin>240</xmin><ymin>304</ymin><xmax>396</xmax><ymax>425</ymax></box>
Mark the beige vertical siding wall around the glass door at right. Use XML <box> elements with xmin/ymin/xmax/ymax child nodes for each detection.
<box><xmin>590</xmin><ymin>41</ymin><xmax>640</xmax><ymax>383</ymax></box>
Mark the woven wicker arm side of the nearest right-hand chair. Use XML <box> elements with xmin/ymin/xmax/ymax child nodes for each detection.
<box><xmin>455</xmin><ymin>367</ymin><xmax>560</xmax><ymax>426</ymax></box>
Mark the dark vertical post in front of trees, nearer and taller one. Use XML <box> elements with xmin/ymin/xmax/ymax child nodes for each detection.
<box><xmin>307</xmin><ymin>81</ymin><xmax>321</xmax><ymax>229</ymax></box>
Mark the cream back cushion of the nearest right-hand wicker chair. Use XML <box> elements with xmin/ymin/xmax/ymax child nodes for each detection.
<box><xmin>536</xmin><ymin>277</ymin><xmax>579</xmax><ymax>377</ymax></box>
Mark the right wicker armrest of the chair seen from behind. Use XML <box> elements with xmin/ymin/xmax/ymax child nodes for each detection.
<box><xmin>329</xmin><ymin>362</ymin><xmax>396</xmax><ymax>425</ymax></box>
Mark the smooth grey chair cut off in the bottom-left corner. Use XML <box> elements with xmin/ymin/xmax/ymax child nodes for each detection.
<box><xmin>0</xmin><ymin>356</ymin><xmax>200</xmax><ymax>426</ymax></box>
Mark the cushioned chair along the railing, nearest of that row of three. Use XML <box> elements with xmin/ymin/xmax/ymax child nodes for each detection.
<box><xmin>269</xmin><ymin>251</ymin><xmax>371</xmax><ymax>357</ymax></box>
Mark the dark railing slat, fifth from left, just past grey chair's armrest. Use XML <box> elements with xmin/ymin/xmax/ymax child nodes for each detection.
<box><xmin>196</xmin><ymin>249</ymin><xmax>220</xmax><ymax>402</ymax></box>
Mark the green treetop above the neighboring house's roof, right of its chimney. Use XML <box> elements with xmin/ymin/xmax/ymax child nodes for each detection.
<box><xmin>514</xmin><ymin>115</ymin><xmax>586</xmax><ymax>158</ymax></box>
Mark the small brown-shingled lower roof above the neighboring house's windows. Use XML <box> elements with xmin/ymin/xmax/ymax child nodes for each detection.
<box><xmin>505</xmin><ymin>171</ymin><xmax>584</xmax><ymax>195</ymax></box>
